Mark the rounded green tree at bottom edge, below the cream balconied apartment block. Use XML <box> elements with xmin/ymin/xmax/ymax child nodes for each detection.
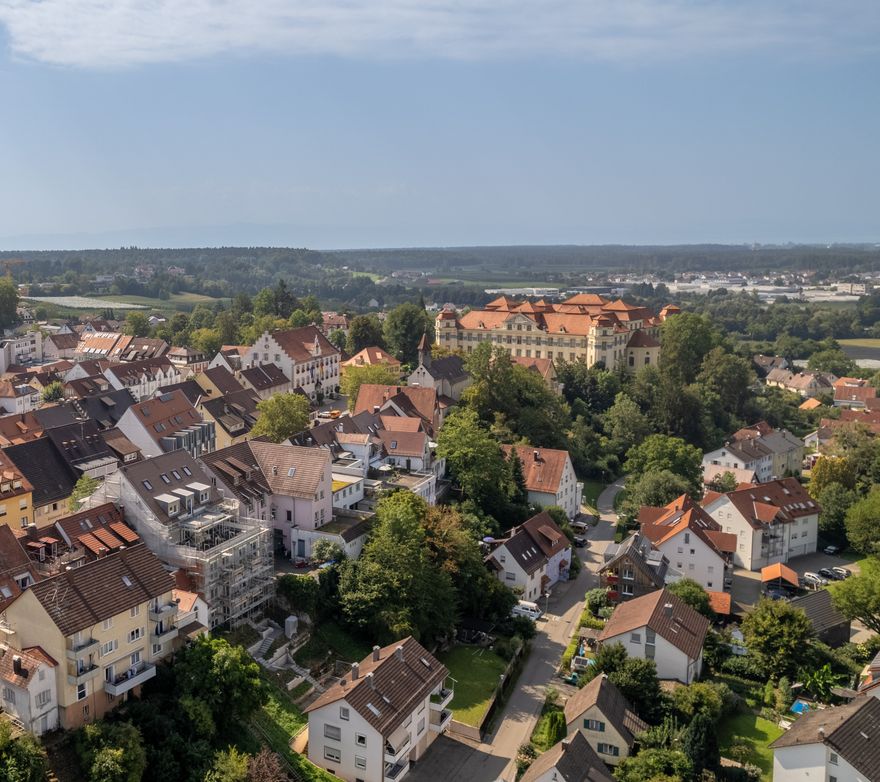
<box><xmin>76</xmin><ymin>722</ymin><xmax>147</xmax><ymax>782</ymax></box>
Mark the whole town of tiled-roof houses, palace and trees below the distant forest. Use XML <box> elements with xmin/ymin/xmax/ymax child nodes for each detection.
<box><xmin>0</xmin><ymin>272</ymin><xmax>880</xmax><ymax>782</ymax></box>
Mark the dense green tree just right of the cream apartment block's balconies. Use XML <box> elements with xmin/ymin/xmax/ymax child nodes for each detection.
<box><xmin>173</xmin><ymin>635</ymin><xmax>268</xmax><ymax>735</ymax></box>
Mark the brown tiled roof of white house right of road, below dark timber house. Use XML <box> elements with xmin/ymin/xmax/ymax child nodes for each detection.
<box><xmin>599</xmin><ymin>589</ymin><xmax>709</xmax><ymax>660</ymax></box>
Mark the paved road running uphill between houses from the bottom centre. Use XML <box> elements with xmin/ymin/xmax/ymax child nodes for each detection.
<box><xmin>408</xmin><ymin>484</ymin><xmax>622</xmax><ymax>782</ymax></box>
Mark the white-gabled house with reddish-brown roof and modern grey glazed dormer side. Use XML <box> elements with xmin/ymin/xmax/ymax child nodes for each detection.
<box><xmin>116</xmin><ymin>390</ymin><xmax>216</xmax><ymax>458</ymax></box>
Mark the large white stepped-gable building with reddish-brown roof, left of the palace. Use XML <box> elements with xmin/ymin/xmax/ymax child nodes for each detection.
<box><xmin>241</xmin><ymin>326</ymin><xmax>340</xmax><ymax>402</ymax></box>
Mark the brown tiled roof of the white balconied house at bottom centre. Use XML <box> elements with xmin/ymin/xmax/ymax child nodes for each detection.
<box><xmin>306</xmin><ymin>637</ymin><xmax>449</xmax><ymax>737</ymax></box>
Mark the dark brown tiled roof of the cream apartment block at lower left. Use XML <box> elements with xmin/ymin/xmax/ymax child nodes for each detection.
<box><xmin>24</xmin><ymin>544</ymin><xmax>174</xmax><ymax>636</ymax></box>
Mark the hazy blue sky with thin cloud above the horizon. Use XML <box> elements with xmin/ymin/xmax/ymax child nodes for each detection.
<box><xmin>0</xmin><ymin>0</ymin><xmax>880</xmax><ymax>249</ymax></box>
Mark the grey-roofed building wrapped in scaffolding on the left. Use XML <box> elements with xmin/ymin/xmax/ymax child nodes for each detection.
<box><xmin>97</xmin><ymin>450</ymin><xmax>273</xmax><ymax>629</ymax></box>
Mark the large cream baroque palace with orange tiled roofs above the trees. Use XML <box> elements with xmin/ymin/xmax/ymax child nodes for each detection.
<box><xmin>435</xmin><ymin>293</ymin><xmax>680</xmax><ymax>372</ymax></box>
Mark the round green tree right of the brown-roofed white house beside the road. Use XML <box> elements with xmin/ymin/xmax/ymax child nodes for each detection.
<box><xmin>742</xmin><ymin>599</ymin><xmax>813</xmax><ymax>680</ymax></box>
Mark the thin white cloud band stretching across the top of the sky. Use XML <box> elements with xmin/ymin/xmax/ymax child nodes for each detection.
<box><xmin>0</xmin><ymin>0</ymin><xmax>880</xmax><ymax>68</ymax></box>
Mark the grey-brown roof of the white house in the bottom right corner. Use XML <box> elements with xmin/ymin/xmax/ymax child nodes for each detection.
<box><xmin>770</xmin><ymin>695</ymin><xmax>880</xmax><ymax>780</ymax></box>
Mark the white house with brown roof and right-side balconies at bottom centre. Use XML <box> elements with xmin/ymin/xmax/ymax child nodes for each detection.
<box><xmin>306</xmin><ymin>638</ymin><xmax>454</xmax><ymax>782</ymax></box>
